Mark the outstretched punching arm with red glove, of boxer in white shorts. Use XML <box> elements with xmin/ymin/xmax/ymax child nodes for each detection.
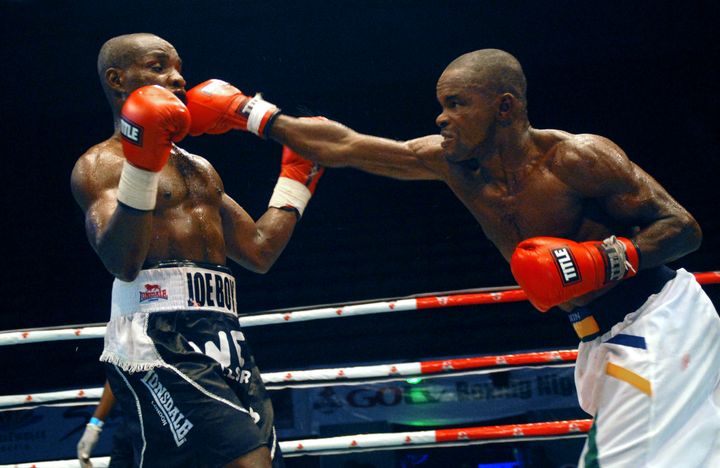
<box><xmin>187</xmin><ymin>79</ymin><xmax>447</xmax><ymax>180</ymax></box>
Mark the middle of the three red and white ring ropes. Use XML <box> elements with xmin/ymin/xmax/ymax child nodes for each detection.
<box><xmin>0</xmin><ymin>349</ymin><xmax>577</xmax><ymax>408</ymax></box>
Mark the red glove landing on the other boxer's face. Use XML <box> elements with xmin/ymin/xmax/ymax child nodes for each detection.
<box><xmin>187</xmin><ymin>79</ymin><xmax>280</xmax><ymax>138</ymax></box>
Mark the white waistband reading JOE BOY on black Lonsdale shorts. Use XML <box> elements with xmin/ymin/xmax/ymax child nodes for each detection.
<box><xmin>110</xmin><ymin>266</ymin><xmax>237</xmax><ymax>319</ymax></box>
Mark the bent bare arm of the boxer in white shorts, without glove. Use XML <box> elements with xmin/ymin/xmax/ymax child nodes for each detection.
<box><xmin>552</xmin><ymin>135</ymin><xmax>702</xmax><ymax>268</ymax></box>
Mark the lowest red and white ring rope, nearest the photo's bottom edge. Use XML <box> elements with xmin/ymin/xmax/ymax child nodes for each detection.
<box><xmin>3</xmin><ymin>419</ymin><xmax>592</xmax><ymax>468</ymax></box>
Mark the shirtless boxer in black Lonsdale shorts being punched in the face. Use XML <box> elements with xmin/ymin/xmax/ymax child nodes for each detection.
<box><xmin>71</xmin><ymin>34</ymin><xmax>321</xmax><ymax>467</ymax></box>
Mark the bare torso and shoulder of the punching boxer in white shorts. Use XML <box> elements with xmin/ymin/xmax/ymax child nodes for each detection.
<box><xmin>434</xmin><ymin>130</ymin><xmax>684</xmax><ymax>260</ymax></box>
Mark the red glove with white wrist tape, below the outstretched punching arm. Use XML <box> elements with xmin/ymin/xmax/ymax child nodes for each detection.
<box><xmin>268</xmin><ymin>146</ymin><xmax>325</xmax><ymax>216</ymax></box>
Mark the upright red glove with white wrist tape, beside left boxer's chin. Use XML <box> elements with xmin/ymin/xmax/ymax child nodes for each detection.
<box><xmin>118</xmin><ymin>85</ymin><xmax>190</xmax><ymax>210</ymax></box>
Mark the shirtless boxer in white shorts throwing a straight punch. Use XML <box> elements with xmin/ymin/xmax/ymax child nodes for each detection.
<box><xmin>183</xmin><ymin>49</ymin><xmax>720</xmax><ymax>467</ymax></box>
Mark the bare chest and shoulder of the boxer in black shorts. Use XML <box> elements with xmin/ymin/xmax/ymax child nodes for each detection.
<box><xmin>72</xmin><ymin>138</ymin><xmax>226</xmax><ymax>265</ymax></box>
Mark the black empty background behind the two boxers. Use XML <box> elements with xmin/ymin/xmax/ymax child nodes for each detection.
<box><xmin>0</xmin><ymin>0</ymin><xmax>720</xmax><ymax>390</ymax></box>
